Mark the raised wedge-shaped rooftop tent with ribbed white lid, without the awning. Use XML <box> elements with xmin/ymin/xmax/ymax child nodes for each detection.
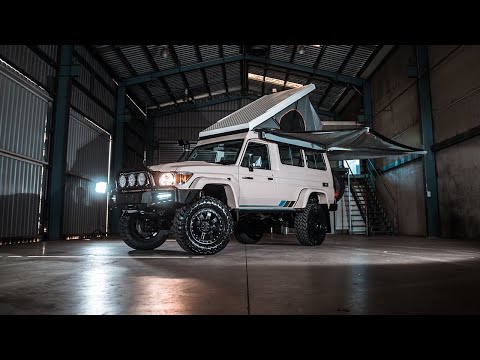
<box><xmin>199</xmin><ymin>84</ymin><xmax>322</xmax><ymax>139</ymax></box>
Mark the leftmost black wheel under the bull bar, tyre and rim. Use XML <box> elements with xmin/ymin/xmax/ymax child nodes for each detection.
<box><xmin>120</xmin><ymin>213</ymin><xmax>169</xmax><ymax>250</ymax></box>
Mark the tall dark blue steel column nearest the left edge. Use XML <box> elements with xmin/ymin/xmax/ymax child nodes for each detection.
<box><xmin>47</xmin><ymin>45</ymin><xmax>75</xmax><ymax>240</ymax></box>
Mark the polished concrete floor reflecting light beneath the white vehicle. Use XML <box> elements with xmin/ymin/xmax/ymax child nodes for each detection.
<box><xmin>0</xmin><ymin>234</ymin><xmax>480</xmax><ymax>315</ymax></box>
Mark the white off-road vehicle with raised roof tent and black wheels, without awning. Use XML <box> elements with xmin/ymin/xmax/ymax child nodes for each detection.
<box><xmin>113</xmin><ymin>85</ymin><xmax>424</xmax><ymax>254</ymax></box>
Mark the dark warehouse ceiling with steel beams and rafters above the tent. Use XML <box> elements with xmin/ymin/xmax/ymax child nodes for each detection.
<box><xmin>91</xmin><ymin>45</ymin><xmax>382</xmax><ymax>112</ymax></box>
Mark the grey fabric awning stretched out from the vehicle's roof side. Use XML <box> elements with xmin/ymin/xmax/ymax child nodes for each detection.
<box><xmin>260</xmin><ymin>127</ymin><xmax>427</xmax><ymax>160</ymax></box>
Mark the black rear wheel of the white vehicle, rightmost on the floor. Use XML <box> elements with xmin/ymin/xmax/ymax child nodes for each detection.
<box><xmin>295</xmin><ymin>204</ymin><xmax>327</xmax><ymax>246</ymax></box>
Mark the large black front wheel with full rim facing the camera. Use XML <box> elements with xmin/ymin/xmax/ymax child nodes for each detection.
<box><xmin>174</xmin><ymin>196</ymin><xmax>233</xmax><ymax>255</ymax></box>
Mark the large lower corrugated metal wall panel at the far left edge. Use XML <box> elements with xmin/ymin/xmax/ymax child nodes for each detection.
<box><xmin>0</xmin><ymin>64</ymin><xmax>51</xmax><ymax>242</ymax></box>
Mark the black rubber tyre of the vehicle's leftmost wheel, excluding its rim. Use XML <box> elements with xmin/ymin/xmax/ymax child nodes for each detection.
<box><xmin>120</xmin><ymin>213</ymin><xmax>169</xmax><ymax>250</ymax></box>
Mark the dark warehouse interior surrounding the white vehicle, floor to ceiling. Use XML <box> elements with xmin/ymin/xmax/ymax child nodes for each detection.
<box><xmin>0</xmin><ymin>44</ymin><xmax>480</xmax><ymax>315</ymax></box>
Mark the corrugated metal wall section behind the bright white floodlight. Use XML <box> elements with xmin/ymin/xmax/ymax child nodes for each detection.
<box><xmin>63</xmin><ymin>110</ymin><xmax>110</xmax><ymax>235</ymax></box>
